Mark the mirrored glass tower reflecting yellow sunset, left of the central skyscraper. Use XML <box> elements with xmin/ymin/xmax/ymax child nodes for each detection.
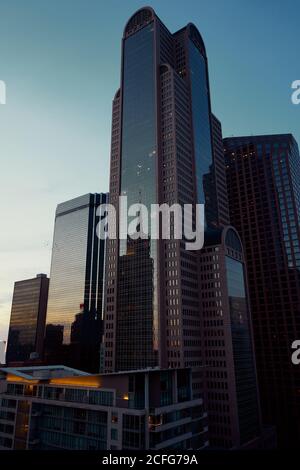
<box><xmin>45</xmin><ymin>194</ymin><xmax>107</xmax><ymax>372</ymax></box>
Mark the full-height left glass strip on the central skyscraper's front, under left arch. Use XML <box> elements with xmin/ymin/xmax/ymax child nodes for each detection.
<box><xmin>116</xmin><ymin>23</ymin><xmax>158</xmax><ymax>370</ymax></box>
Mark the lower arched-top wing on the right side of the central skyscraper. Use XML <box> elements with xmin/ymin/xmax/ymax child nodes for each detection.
<box><xmin>200</xmin><ymin>226</ymin><xmax>262</xmax><ymax>449</ymax></box>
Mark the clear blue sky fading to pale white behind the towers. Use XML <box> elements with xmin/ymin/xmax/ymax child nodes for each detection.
<box><xmin>0</xmin><ymin>0</ymin><xmax>300</xmax><ymax>340</ymax></box>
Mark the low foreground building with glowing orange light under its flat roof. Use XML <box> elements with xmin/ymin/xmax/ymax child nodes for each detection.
<box><xmin>0</xmin><ymin>366</ymin><xmax>208</xmax><ymax>452</ymax></box>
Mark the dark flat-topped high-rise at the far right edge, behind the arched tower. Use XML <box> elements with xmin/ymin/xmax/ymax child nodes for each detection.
<box><xmin>224</xmin><ymin>134</ymin><xmax>300</xmax><ymax>446</ymax></box>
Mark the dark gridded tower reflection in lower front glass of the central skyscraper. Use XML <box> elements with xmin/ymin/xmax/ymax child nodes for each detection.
<box><xmin>116</xmin><ymin>239</ymin><xmax>157</xmax><ymax>370</ymax></box>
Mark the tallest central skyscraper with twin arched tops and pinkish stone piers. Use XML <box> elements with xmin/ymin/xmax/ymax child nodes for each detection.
<box><xmin>104</xmin><ymin>7</ymin><xmax>218</xmax><ymax>376</ymax></box>
